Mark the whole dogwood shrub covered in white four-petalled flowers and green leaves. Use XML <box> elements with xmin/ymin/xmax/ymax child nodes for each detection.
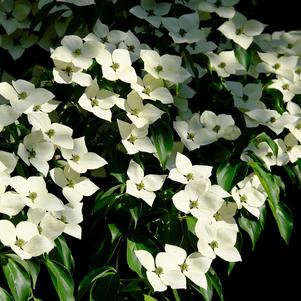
<box><xmin>0</xmin><ymin>0</ymin><xmax>301</xmax><ymax>301</ymax></box>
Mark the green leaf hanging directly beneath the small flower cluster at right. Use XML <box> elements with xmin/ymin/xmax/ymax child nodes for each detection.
<box><xmin>238</xmin><ymin>206</ymin><xmax>266</xmax><ymax>250</ymax></box>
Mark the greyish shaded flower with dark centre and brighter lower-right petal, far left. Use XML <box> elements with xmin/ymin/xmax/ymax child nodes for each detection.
<box><xmin>18</xmin><ymin>130</ymin><xmax>54</xmax><ymax>176</ymax></box>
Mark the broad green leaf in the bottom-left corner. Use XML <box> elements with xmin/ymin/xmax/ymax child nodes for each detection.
<box><xmin>2</xmin><ymin>258</ymin><xmax>31</xmax><ymax>301</ymax></box>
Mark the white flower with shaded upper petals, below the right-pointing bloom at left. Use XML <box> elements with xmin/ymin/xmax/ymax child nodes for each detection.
<box><xmin>50</xmin><ymin>165</ymin><xmax>99</xmax><ymax>206</ymax></box>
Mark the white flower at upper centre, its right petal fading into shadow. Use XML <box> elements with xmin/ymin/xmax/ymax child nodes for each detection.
<box><xmin>140</xmin><ymin>49</ymin><xmax>191</xmax><ymax>84</ymax></box>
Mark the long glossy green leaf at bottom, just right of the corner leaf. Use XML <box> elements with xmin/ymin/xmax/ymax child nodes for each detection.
<box><xmin>45</xmin><ymin>259</ymin><xmax>75</xmax><ymax>301</ymax></box>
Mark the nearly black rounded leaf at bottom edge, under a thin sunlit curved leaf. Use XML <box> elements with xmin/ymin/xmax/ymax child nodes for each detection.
<box><xmin>89</xmin><ymin>272</ymin><xmax>120</xmax><ymax>301</ymax></box>
